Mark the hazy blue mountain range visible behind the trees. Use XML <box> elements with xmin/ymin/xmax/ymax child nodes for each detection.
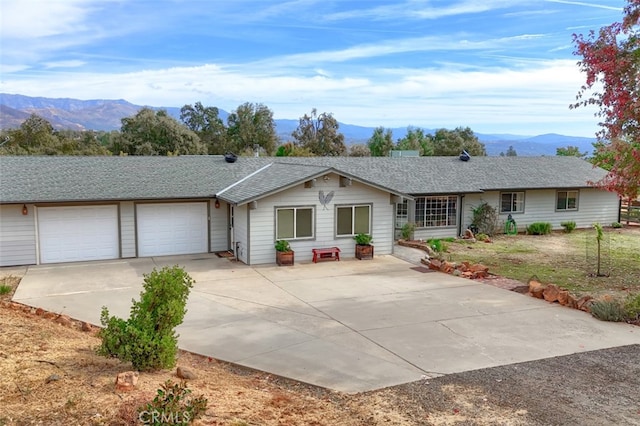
<box><xmin>0</xmin><ymin>93</ymin><xmax>596</xmax><ymax>156</ymax></box>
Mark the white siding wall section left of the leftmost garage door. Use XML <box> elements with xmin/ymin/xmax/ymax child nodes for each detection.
<box><xmin>0</xmin><ymin>204</ymin><xmax>36</xmax><ymax>266</ymax></box>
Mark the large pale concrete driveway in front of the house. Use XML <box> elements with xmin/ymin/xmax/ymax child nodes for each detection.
<box><xmin>7</xmin><ymin>255</ymin><xmax>640</xmax><ymax>392</ymax></box>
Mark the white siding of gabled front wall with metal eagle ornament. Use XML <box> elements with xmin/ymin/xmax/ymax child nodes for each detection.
<box><xmin>249</xmin><ymin>174</ymin><xmax>394</xmax><ymax>265</ymax></box>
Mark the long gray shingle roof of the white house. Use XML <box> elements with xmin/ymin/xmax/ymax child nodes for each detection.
<box><xmin>0</xmin><ymin>156</ymin><xmax>606</xmax><ymax>203</ymax></box>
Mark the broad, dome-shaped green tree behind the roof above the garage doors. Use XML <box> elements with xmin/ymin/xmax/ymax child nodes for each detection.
<box><xmin>111</xmin><ymin>108</ymin><xmax>207</xmax><ymax>155</ymax></box>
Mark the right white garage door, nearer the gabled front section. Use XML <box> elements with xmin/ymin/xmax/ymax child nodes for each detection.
<box><xmin>136</xmin><ymin>203</ymin><xmax>209</xmax><ymax>257</ymax></box>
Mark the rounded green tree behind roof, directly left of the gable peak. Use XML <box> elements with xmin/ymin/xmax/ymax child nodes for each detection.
<box><xmin>227</xmin><ymin>102</ymin><xmax>278</xmax><ymax>155</ymax></box>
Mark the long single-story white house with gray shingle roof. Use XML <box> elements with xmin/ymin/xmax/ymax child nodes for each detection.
<box><xmin>0</xmin><ymin>156</ymin><xmax>619</xmax><ymax>266</ymax></box>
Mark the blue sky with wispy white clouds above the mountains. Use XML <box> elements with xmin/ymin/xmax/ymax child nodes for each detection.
<box><xmin>0</xmin><ymin>0</ymin><xmax>625</xmax><ymax>136</ymax></box>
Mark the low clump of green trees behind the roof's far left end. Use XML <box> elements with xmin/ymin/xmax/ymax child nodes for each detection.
<box><xmin>0</xmin><ymin>114</ymin><xmax>110</xmax><ymax>155</ymax></box>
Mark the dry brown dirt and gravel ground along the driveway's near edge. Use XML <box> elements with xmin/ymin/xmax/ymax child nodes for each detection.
<box><xmin>0</xmin><ymin>278</ymin><xmax>640</xmax><ymax>426</ymax></box>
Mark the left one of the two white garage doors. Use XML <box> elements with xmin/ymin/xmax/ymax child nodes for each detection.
<box><xmin>38</xmin><ymin>205</ymin><xmax>120</xmax><ymax>263</ymax></box>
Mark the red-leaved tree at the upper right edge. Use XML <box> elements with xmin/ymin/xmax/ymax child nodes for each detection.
<box><xmin>570</xmin><ymin>0</ymin><xmax>640</xmax><ymax>199</ymax></box>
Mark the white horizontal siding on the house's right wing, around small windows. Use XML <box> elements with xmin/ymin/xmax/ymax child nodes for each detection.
<box><xmin>464</xmin><ymin>188</ymin><xmax>619</xmax><ymax>232</ymax></box>
